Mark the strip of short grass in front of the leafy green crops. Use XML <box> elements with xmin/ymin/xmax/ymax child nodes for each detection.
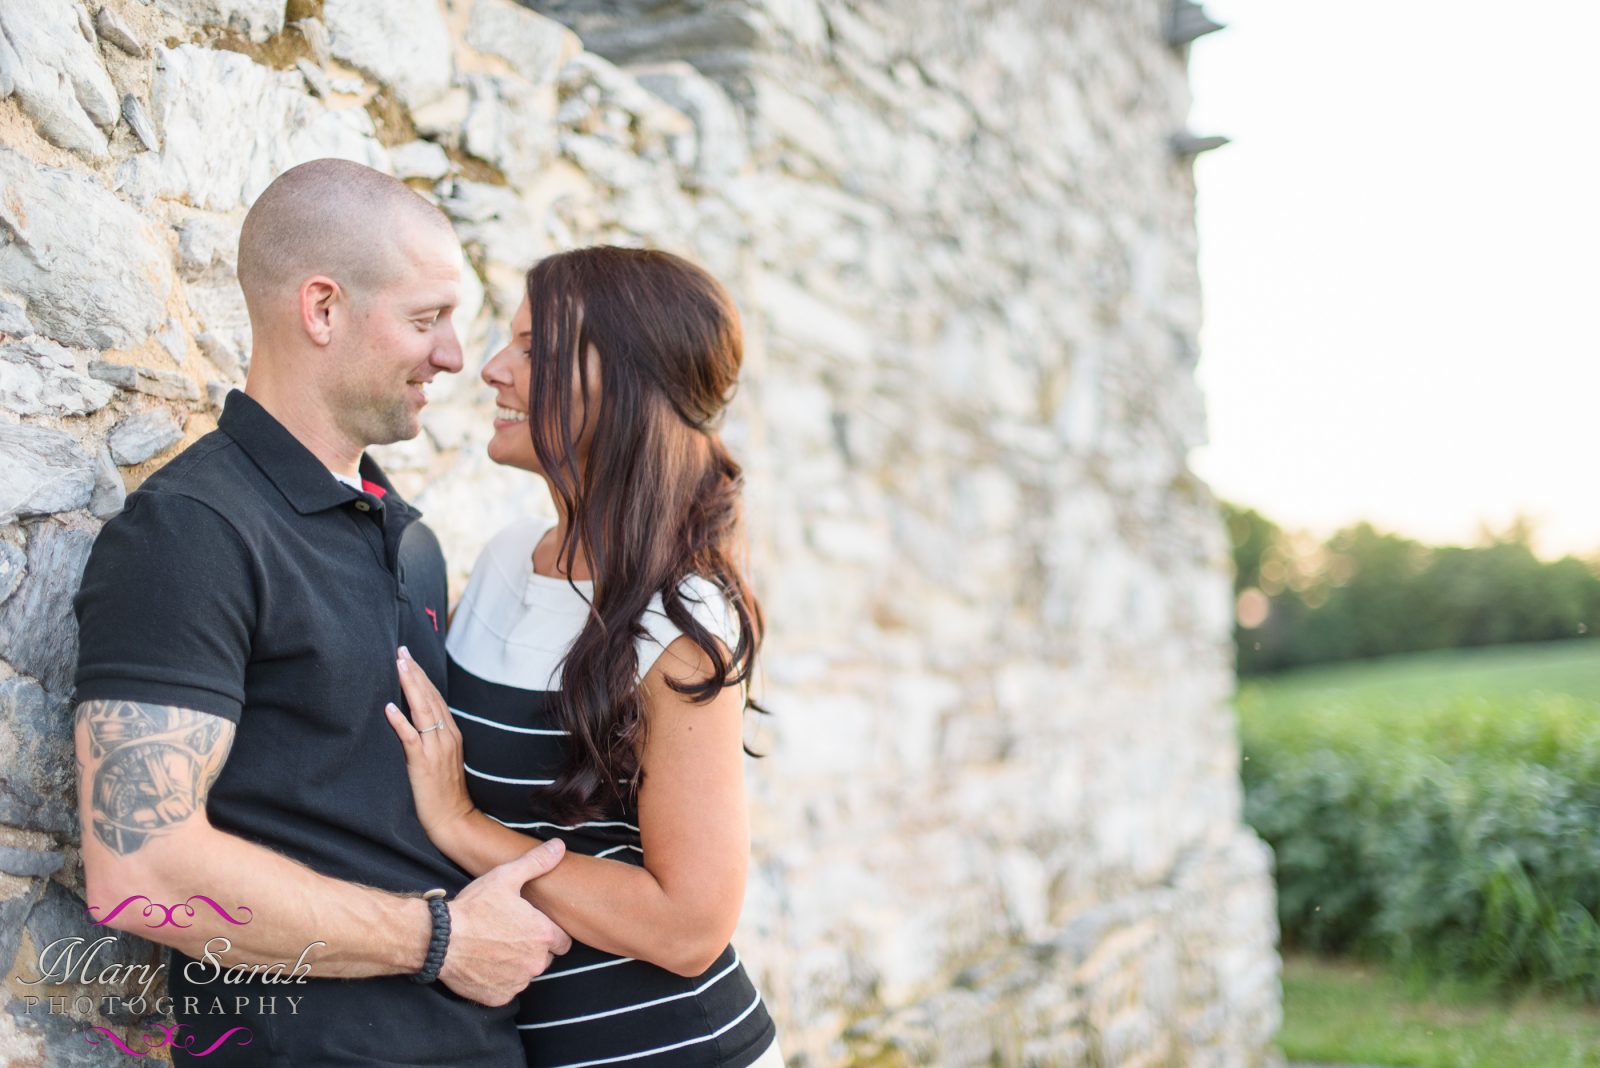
<box><xmin>1278</xmin><ymin>954</ymin><xmax>1600</xmax><ymax>1068</ymax></box>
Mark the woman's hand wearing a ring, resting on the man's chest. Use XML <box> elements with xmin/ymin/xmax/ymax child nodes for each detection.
<box><xmin>384</xmin><ymin>646</ymin><xmax>474</xmax><ymax>852</ymax></box>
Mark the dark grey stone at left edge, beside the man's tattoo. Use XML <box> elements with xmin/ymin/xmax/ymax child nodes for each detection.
<box><xmin>0</xmin><ymin>678</ymin><xmax>78</xmax><ymax>831</ymax></box>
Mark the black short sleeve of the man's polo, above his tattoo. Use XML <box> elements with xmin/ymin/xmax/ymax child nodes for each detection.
<box><xmin>72</xmin><ymin>492</ymin><xmax>256</xmax><ymax>723</ymax></box>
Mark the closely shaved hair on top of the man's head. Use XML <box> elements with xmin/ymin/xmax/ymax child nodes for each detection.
<box><xmin>238</xmin><ymin>158</ymin><xmax>454</xmax><ymax>321</ymax></box>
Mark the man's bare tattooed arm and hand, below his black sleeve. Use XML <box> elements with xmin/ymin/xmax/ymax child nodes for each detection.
<box><xmin>75</xmin><ymin>700</ymin><xmax>570</xmax><ymax>1004</ymax></box>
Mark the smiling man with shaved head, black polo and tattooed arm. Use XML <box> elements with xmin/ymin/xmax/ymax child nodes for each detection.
<box><xmin>75</xmin><ymin>160</ymin><xmax>571</xmax><ymax>1068</ymax></box>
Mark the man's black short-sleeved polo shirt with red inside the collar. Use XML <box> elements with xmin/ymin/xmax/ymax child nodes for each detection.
<box><xmin>74</xmin><ymin>392</ymin><xmax>525</xmax><ymax>1068</ymax></box>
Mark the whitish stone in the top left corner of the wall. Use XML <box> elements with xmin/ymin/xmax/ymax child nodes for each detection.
<box><xmin>0</xmin><ymin>0</ymin><xmax>117</xmax><ymax>157</ymax></box>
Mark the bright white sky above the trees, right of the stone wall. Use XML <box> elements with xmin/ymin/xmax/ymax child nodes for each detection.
<box><xmin>1190</xmin><ymin>0</ymin><xmax>1600</xmax><ymax>555</ymax></box>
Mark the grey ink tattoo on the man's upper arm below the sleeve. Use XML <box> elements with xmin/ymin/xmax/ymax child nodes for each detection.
<box><xmin>78</xmin><ymin>700</ymin><xmax>234</xmax><ymax>855</ymax></box>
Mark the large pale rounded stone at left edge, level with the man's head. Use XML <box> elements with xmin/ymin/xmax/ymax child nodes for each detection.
<box><xmin>0</xmin><ymin>147</ymin><xmax>171</xmax><ymax>349</ymax></box>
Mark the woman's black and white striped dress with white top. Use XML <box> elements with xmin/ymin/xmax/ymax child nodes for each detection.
<box><xmin>446</xmin><ymin>520</ymin><xmax>776</xmax><ymax>1068</ymax></box>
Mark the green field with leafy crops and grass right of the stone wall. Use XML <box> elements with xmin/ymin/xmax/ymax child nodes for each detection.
<box><xmin>1237</xmin><ymin>640</ymin><xmax>1600</xmax><ymax>1068</ymax></box>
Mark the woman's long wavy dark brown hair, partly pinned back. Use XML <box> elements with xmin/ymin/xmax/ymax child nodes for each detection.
<box><xmin>526</xmin><ymin>245</ymin><xmax>766</xmax><ymax>822</ymax></box>
